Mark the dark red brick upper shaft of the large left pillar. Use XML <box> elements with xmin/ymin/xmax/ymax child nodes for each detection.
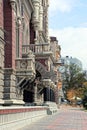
<box><xmin>3</xmin><ymin>0</ymin><xmax>16</xmax><ymax>68</ymax></box>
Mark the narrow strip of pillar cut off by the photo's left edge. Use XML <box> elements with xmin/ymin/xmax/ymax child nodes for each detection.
<box><xmin>0</xmin><ymin>0</ymin><xmax>5</xmax><ymax>105</ymax></box>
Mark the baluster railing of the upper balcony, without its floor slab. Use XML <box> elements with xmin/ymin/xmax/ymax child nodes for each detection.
<box><xmin>22</xmin><ymin>44</ymin><xmax>50</xmax><ymax>54</ymax></box>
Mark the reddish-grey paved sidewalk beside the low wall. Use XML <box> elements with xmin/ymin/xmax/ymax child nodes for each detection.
<box><xmin>20</xmin><ymin>106</ymin><xmax>87</xmax><ymax>130</ymax></box>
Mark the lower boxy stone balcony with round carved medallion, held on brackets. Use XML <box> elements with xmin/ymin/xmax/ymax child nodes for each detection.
<box><xmin>16</xmin><ymin>51</ymin><xmax>35</xmax><ymax>79</ymax></box>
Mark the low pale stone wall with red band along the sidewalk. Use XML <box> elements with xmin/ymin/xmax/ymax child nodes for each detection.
<box><xmin>0</xmin><ymin>106</ymin><xmax>47</xmax><ymax>130</ymax></box>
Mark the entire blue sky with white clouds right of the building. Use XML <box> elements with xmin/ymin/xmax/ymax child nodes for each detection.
<box><xmin>49</xmin><ymin>0</ymin><xmax>87</xmax><ymax>70</ymax></box>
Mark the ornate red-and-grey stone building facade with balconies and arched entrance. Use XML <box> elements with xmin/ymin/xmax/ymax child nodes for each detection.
<box><xmin>0</xmin><ymin>0</ymin><xmax>61</xmax><ymax>105</ymax></box>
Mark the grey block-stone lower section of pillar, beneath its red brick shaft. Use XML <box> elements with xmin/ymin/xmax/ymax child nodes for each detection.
<box><xmin>4</xmin><ymin>68</ymin><xmax>24</xmax><ymax>105</ymax></box>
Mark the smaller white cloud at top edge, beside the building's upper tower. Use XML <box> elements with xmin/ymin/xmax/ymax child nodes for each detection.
<box><xmin>50</xmin><ymin>0</ymin><xmax>77</xmax><ymax>12</ymax></box>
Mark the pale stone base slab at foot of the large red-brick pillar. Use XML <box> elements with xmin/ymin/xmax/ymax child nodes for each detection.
<box><xmin>3</xmin><ymin>99</ymin><xmax>25</xmax><ymax>106</ymax></box>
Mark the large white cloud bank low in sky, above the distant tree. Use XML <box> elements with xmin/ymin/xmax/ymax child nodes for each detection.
<box><xmin>49</xmin><ymin>27</ymin><xmax>87</xmax><ymax>68</ymax></box>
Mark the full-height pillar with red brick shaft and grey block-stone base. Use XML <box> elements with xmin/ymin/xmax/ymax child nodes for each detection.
<box><xmin>3</xmin><ymin>0</ymin><xmax>24</xmax><ymax>106</ymax></box>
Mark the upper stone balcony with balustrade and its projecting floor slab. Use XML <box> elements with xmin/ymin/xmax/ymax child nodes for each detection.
<box><xmin>22</xmin><ymin>43</ymin><xmax>52</xmax><ymax>57</ymax></box>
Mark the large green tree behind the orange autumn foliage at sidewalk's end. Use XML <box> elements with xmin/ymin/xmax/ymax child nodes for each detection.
<box><xmin>63</xmin><ymin>63</ymin><xmax>86</xmax><ymax>99</ymax></box>
